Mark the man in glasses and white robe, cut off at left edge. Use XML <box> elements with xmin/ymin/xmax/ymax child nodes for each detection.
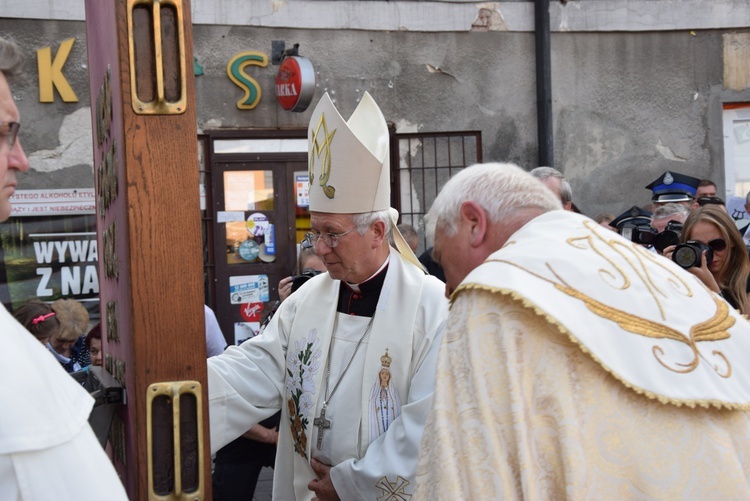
<box><xmin>0</xmin><ymin>38</ymin><xmax>127</xmax><ymax>500</ymax></box>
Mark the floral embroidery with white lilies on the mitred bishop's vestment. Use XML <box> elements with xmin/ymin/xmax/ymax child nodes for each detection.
<box><xmin>286</xmin><ymin>329</ymin><xmax>320</xmax><ymax>459</ymax></box>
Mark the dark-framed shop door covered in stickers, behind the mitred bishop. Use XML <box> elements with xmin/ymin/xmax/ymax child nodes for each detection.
<box><xmin>202</xmin><ymin>129</ymin><xmax>310</xmax><ymax>344</ymax></box>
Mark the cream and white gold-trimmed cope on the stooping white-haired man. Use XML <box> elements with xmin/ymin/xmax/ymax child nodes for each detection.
<box><xmin>415</xmin><ymin>211</ymin><xmax>750</xmax><ymax>500</ymax></box>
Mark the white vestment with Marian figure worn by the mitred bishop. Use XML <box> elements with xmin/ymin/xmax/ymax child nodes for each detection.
<box><xmin>209</xmin><ymin>251</ymin><xmax>447</xmax><ymax>499</ymax></box>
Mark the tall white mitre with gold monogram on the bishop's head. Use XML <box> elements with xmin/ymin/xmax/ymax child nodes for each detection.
<box><xmin>307</xmin><ymin>92</ymin><xmax>423</xmax><ymax>269</ymax></box>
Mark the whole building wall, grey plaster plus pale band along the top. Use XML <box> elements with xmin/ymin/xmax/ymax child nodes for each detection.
<box><xmin>0</xmin><ymin>0</ymin><xmax>750</xmax><ymax>216</ymax></box>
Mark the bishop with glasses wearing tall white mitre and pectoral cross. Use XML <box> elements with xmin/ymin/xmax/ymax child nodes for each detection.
<box><xmin>208</xmin><ymin>93</ymin><xmax>447</xmax><ymax>500</ymax></box>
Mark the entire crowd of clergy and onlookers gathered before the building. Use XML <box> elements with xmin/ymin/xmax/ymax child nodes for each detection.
<box><xmin>0</xmin><ymin>33</ymin><xmax>750</xmax><ymax>501</ymax></box>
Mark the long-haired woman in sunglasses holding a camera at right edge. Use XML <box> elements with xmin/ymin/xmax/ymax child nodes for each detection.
<box><xmin>664</xmin><ymin>204</ymin><xmax>750</xmax><ymax>314</ymax></box>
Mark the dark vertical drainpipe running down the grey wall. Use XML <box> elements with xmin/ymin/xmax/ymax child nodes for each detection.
<box><xmin>534</xmin><ymin>0</ymin><xmax>555</xmax><ymax>167</ymax></box>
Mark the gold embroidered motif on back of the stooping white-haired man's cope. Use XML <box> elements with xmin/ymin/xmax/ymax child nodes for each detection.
<box><xmin>487</xmin><ymin>221</ymin><xmax>735</xmax><ymax>378</ymax></box>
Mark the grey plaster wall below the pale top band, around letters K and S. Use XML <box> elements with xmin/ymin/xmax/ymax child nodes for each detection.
<box><xmin>0</xmin><ymin>19</ymin><xmax>750</xmax><ymax>216</ymax></box>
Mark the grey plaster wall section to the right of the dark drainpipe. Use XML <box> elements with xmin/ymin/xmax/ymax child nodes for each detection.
<box><xmin>552</xmin><ymin>31</ymin><xmax>723</xmax><ymax>215</ymax></box>
